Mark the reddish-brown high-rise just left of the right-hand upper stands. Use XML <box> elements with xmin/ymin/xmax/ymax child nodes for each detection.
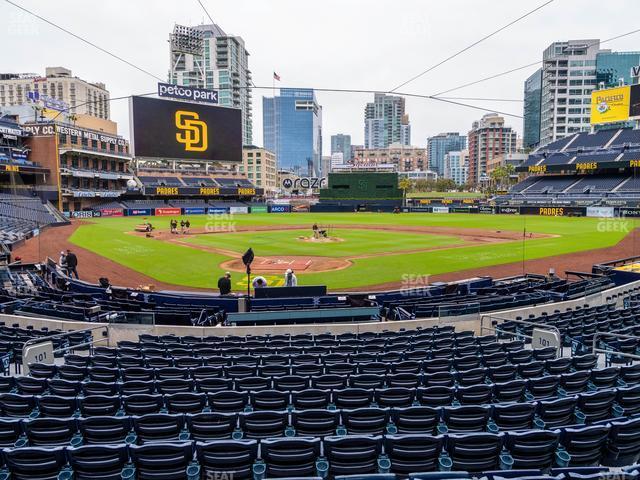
<box><xmin>469</xmin><ymin>113</ymin><xmax>517</xmax><ymax>184</ymax></box>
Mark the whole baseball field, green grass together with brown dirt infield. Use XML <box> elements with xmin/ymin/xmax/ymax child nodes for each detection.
<box><xmin>46</xmin><ymin>213</ymin><xmax>635</xmax><ymax>290</ymax></box>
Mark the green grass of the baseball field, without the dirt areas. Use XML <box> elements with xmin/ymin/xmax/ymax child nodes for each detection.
<box><xmin>71</xmin><ymin>213</ymin><xmax>635</xmax><ymax>289</ymax></box>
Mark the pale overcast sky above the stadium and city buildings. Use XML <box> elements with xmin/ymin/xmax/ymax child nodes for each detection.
<box><xmin>0</xmin><ymin>0</ymin><xmax>640</xmax><ymax>154</ymax></box>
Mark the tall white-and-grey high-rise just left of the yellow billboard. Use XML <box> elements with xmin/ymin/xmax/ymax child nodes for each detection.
<box><xmin>540</xmin><ymin>39</ymin><xmax>601</xmax><ymax>145</ymax></box>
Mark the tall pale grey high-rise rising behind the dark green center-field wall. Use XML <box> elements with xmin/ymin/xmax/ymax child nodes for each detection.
<box><xmin>364</xmin><ymin>93</ymin><xmax>411</xmax><ymax>148</ymax></box>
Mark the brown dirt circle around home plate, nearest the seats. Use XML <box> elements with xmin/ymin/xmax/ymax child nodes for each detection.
<box><xmin>220</xmin><ymin>256</ymin><xmax>351</xmax><ymax>274</ymax></box>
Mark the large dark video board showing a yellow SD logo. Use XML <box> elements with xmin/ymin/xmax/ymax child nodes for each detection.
<box><xmin>130</xmin><ymin>97</ymin><xmax>242</xmax><ymax>162</ymax></box>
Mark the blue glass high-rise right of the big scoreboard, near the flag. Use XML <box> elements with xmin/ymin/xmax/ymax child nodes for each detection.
<box><xmin>262</xmin><ymin>88</ymin><xmax>322</xmax><ymax>175</ymax></box>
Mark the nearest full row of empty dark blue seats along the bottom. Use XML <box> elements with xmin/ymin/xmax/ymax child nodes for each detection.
<box><xmin>2</xmin><ymin>420</ymin><xmax>640</xmax><ymax>480</ymax></box>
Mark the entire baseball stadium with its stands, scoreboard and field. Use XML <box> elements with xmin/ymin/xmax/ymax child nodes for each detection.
<box><xmin>5</xmin><ymin>9</ymin><xmax>640</xmax><ymax>480</ymax></box>
